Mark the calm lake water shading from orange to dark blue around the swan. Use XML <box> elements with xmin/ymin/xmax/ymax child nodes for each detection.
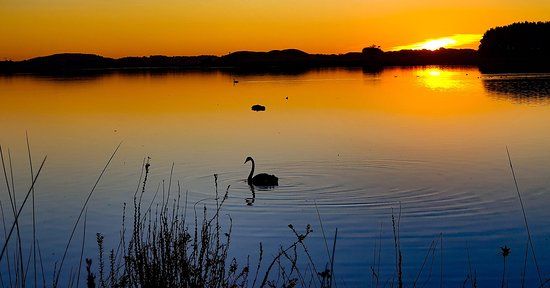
<box><xmin>0</xmin><ymin>67</ymin><xmax>550</xmax><ymax>287</ymax></box>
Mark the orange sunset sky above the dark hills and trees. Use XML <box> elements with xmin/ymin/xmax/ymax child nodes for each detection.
<box><xmin>0</xmin><ymin>0</ymin><xmax>550</xmax><ymax>60</ymax></box>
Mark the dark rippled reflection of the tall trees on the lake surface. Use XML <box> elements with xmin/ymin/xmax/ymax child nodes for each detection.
<box><xmin>483</xmin><ymin>75</ymin><xmax>550</xmax><ymax>103</ymax></box>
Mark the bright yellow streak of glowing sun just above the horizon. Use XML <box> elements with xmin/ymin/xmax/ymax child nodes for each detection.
<box><xmin>392</xmin><ymin>34</ymin><xmax>483</xmax><ymax>51</ymax></box>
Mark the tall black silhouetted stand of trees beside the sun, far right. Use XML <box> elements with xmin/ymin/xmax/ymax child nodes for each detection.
<box><xmin>479</xmin><ymin>22</ymin><xmax>550</xmax><ymax>71</ymax></box>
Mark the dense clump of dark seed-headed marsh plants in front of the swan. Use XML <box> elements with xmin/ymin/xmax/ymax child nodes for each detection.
<box><xmin>86</xmin><ymin>159</ymin><xmax>331</xmax><ymax>287</ymax></box>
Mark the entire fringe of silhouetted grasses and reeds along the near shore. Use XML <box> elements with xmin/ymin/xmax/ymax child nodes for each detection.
<box><xmin>0</xmin><ymin>147</ymin><xmax>550</xmax><ymax>288</ymax></box>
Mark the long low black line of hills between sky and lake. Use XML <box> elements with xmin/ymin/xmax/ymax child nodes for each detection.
<box><xmin>0</xmin><ymin>48</ymin><xmax>477</xmax><ymax>73</ymax></box>
